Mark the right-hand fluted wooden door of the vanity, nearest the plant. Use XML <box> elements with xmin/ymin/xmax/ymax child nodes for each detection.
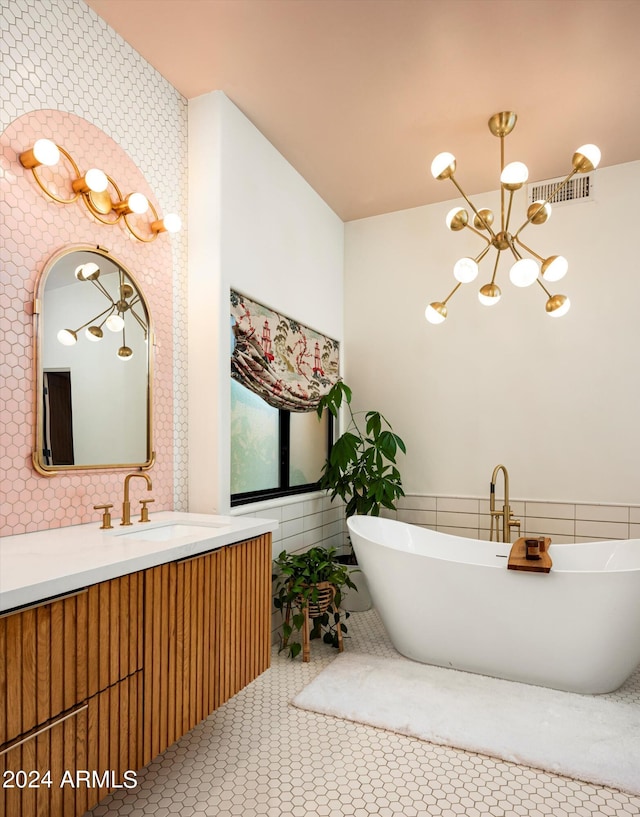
<box><xmin>144</xmin><ymin>534</ymin><xmax>271</xmax><ymax>762</ymax></box>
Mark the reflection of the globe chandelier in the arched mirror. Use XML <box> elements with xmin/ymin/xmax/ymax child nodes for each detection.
<box><xmin>57</xmin><ymin>261</ymin><xmax>148</xmax><ymax>360</ymax></box>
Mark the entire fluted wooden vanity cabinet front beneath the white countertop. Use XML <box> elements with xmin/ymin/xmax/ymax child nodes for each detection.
<box><xmin>0</xmin><ymin>533</ymin><xmax>271</xmax><ymax>817</ymax></box>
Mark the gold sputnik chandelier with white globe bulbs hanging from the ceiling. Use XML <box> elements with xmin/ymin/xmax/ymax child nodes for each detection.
<box><xmin>425</xmin><ymin>111</ymin><xmax>600</xmax><ymax>323</ymax></box>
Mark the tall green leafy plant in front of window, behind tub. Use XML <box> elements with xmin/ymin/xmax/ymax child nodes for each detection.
<box><xmin>317</xmin><ymin>380</ymin><xmax>407</xmax><ymax>610</ymax></box>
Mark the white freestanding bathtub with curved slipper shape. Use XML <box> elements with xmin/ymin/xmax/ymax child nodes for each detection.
<box><xmin>348</xmin><ymin>516</ymin><xmax>640</xmax><ymax>693</ymax></box>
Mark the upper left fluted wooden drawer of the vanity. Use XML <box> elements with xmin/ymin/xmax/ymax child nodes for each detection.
<box><xmin>0</xmin><ymin>574</ymin><xmax>143</xmax><ymax>749</ymax></box>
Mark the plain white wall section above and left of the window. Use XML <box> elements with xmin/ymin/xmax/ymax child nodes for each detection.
<box><xmin>189</xmin><ymin>91</ymin><xmax>344</xmax><ymax>515</ymax></box>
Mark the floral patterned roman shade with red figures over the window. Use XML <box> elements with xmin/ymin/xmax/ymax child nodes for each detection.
<box><xmin>231</xmin><ymin>290</ymin><xmax>340</xmax><ymax>411</ymax></box>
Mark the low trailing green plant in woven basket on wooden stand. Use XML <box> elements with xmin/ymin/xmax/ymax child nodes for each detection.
<box><xmin>273</xmin><ymin>546</ymin><xmax>355</xmax><ymax>661</ymax></box>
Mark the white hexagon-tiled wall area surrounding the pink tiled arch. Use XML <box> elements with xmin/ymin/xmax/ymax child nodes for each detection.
<box><xmin>0</xmin><ymin>0</ymin><xmax>187</xmax><ymax>510</ymax></box>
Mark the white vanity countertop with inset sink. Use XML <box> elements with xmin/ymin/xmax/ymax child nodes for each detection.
<box><xmin>0</xmin><ymin>511</ymin><xmax>278</xmax><ymax>612</ymax></box>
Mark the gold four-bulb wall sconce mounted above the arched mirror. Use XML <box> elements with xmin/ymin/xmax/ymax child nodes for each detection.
<box><xmin>19</xmin><ymin>139</ymin><xmax>182</xmax><ymax>243</ymax></box>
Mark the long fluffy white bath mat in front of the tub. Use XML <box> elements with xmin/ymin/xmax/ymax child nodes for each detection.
<box><xmin>293</xmin><ymin>653</ymin><xmax>640</xmax><ymax>794</ymax></box>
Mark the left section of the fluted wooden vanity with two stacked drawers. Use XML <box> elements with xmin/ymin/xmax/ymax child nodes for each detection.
<box><xmin>0</xmin><ymin>573</ymin><xmax>144</xmax><ymax>817</ymax></box>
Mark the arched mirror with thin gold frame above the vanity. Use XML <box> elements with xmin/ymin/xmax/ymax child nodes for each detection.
<box><xmin>33</xmin><ymin>245</ymin><xmax>155</xmax><ymax>476</ymax></box>
